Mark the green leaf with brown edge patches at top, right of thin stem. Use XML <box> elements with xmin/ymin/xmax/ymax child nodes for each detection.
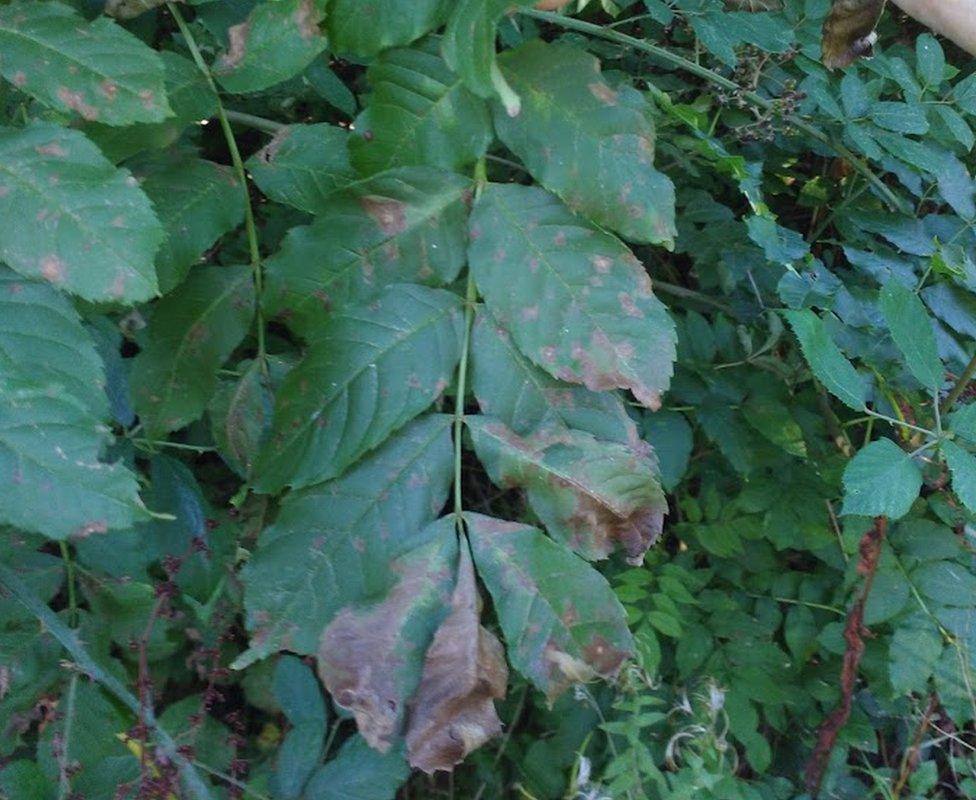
<box><xmin>213</xmin><ymin>0</ymin><xmax>326</xmax><ymax>93</ymax></box>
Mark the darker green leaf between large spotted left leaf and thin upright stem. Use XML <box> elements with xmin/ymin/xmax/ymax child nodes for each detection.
<box><xmin>142</xmin><ymin>158</ymin><xmax>244</xmax><ymax>294</ymax></box>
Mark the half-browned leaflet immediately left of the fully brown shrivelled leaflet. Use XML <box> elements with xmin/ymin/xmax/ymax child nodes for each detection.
<box><xmin>318</xmin><ymin>517</ymin><xmax>458</xmax><ymax>753</ymax></box>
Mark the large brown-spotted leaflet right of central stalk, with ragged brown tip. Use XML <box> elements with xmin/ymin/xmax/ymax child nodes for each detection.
<box><xmin>468</xmin><ymin>184</ymin><xmax>675</xmax><ymax>408</ymax></box>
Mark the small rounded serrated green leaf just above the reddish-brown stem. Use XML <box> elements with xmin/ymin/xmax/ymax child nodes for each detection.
<box><xmin>843</xmin><ymin>439</ymin><xmax>922</xmax><ymax>519</ymax></box>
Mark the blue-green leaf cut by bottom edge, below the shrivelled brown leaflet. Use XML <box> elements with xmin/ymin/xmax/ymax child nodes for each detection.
<box><xmin>305</xmin><ymin>736</ymin><xmax>410</xmax><ymax>800</ymax></box>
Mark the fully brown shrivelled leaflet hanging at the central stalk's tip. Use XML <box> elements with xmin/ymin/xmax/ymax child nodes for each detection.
<box><xmin>407</xmin><ymin>546</ymin><xmax>508</xmax><ymax>774</ymax></box>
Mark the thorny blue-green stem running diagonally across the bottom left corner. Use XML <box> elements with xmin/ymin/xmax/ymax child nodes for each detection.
<box><xmin>0</xmin><ymin>564</ymin><xmax>213</xmax><ymax>800</ymax></box>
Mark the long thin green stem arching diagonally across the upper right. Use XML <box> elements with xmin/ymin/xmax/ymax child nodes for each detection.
<box><xmin>519</xmin><ymin>8</ymin><xmax>912</xmax><ymax>214</ymax></box>
